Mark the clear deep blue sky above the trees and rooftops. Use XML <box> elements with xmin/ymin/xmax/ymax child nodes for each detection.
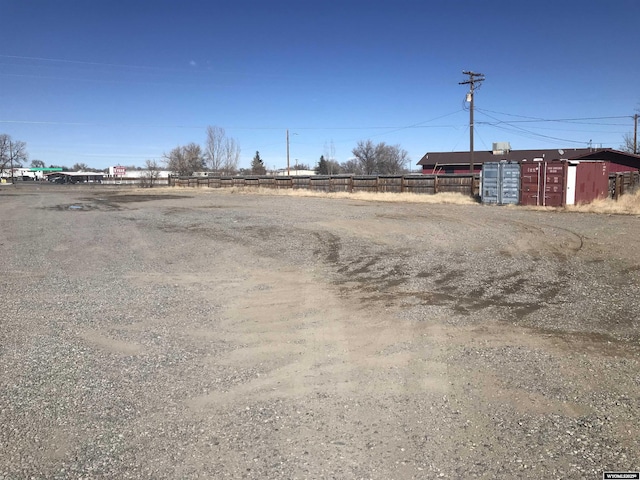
<box><xmin>0</xmin><ymin>0</ymin><xmax>640</xmax><ymax>168</ymax></box>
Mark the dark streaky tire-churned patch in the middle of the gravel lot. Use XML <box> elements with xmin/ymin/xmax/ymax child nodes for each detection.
<box><xmin>314</xmin><ymin>223</ymin><xmax>565</xmax><ymax>324</ymax></box>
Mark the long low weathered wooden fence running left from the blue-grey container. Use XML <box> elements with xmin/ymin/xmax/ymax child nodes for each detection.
<box><xmin>169</xmin><ymin>174</ymin><xmax>480</xmax><ymax>196</ymax></box>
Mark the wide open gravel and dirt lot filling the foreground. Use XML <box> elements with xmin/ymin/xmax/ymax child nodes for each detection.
<box><xmin>0</xmin><ymin>185</ymin><xmax>640</xmax><ymax>480</ymax></box>
